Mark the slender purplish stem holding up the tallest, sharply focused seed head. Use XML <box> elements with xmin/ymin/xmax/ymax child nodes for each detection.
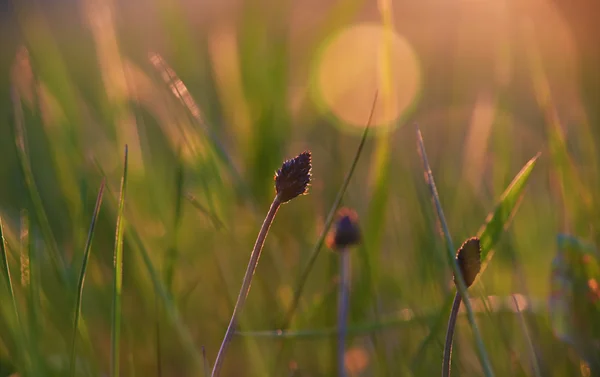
<box><xmin>211</xmin><ymin>195</ymin><xmax>281</xmax><ymax>377</ymax></box>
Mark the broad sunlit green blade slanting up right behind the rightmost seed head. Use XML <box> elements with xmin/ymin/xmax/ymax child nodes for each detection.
<box><xmin>475</xmin><ymin>153</ymin><xmax>540</xmax><ymax>281</ymax></box>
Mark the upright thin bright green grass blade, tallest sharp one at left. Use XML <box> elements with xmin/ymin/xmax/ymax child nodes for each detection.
<box><xmin>110</xmin><ymin>145</ymin><xmax>127</xmax><ymax>377</ymax></box>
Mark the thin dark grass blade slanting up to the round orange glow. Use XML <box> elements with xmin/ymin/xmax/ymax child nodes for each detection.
<box><xmin>280</xmin><ymin>92</ymin><xmax>378</xmax><ymax>329</ymax></box>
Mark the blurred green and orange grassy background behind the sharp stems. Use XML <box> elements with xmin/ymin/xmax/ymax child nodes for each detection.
<box><xmin>0</xmin><ymin>0</ymin><xmax>600</xmax><ymax>376</ymax></box>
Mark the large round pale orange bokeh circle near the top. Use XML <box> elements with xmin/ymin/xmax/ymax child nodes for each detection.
<box><xmin>313</xmin><ymin>24</ymin><xmax>421</xmax><ymax>131</ymax></box>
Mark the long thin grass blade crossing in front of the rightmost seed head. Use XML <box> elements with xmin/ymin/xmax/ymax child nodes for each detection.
<box><xmin>417</xmin><ymin>128</ymin><xmax>494</xmax><ymax>377</ymax></box>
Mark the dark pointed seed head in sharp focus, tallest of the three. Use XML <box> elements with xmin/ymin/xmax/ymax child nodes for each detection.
<box><xmin>275</xmin><ymin>151</ymin><xmax>312</xmax><ymax>203</ymax></box>
